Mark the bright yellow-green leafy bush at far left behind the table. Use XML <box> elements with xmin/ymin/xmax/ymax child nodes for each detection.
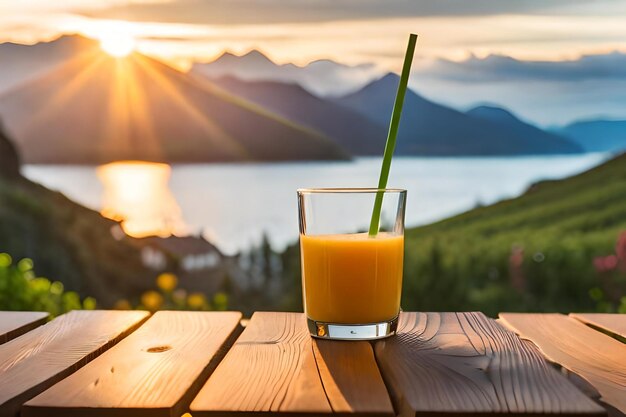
<box><xmin>0</xmin><ymin>253</ymin><xmax>96</xmax><ymax>317</ymax></box>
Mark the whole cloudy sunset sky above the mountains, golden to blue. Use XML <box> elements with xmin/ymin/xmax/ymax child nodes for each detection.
<box><xmin>0</xmin><ymin>0</ymin><xmax>626</xmax><ymax>126</ymax></box>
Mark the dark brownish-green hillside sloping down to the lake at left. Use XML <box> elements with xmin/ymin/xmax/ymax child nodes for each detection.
<box><xmin>0</xmin><ymin>176</ymin><xmax>156</xmax><ymax>307</ymax></box>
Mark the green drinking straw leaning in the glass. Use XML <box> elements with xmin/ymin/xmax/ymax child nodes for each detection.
<box><xmin>369</xmin><ymin>33</ymin><xmax>417</xmax><ymax>236</ymax></box>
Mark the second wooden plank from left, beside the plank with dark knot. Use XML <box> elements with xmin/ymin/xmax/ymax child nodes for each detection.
<box><xmin>0</xmin><ymin>311</ymin><xmax>148</xmax><ymax>417</ymax></box>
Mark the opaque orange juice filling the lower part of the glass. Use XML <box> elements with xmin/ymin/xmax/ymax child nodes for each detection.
<box><xmin>300</xmin><ymin>233</ymin><xmax>404</xmax><ymax>324</ymax></box>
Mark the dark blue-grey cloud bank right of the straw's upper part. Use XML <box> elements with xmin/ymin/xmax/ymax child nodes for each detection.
<box><xmin>422</xmin><ymin>52</ymin><xmax>626</xmax><ymax>83</ymax></box>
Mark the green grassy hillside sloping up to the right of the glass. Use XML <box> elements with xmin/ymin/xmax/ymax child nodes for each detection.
<box><xmin>403</xmin><ymin>154</ymin><xmax>626</xmax><ymax>314</ymax></box>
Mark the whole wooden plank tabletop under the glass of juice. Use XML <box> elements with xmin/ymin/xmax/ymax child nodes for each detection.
<box><xmin>0</xmin><ymin>311</ymin><xmax>626</xmax><ymax>417</ymax></box>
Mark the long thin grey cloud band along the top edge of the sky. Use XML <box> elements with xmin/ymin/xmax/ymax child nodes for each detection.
<box><xmin>78</xmin><ymin>0</ymin><xmax>608</xmax><ymax>24</ymax></box>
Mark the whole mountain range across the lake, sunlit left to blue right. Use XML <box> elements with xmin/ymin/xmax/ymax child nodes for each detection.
<box><xmin>0</xmin><ymin>36</ymin><xmax>626</xmax><ymax>164</ymax></box>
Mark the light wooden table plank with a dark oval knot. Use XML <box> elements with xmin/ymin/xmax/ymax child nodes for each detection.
<box><xmin>22</xmin><ymin>311</ymin><xmax>241</xmax><ymax>417</ymax></box>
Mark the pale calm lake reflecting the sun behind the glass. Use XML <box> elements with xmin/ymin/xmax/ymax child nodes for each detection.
<box><xmin>24</xmin><ymin>153</ymin><xmax>609</xmax><ymax>254</ymax></box>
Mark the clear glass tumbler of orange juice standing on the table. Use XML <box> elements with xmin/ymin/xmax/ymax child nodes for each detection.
<box><xmin>298</xmin><ymin>188</ymin><xmax>406</xmax><ymax>340</ymax></box>
